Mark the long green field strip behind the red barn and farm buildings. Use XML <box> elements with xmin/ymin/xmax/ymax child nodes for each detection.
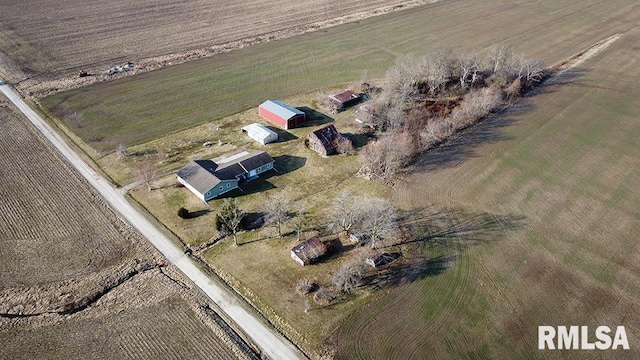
<box><xmin>42</xmin><ymin>0</ymin><xmax>637</xmax><ymax>153</ymax></box>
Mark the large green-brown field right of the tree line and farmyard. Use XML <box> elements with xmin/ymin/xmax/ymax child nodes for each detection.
<box><xmin>336</xmin><ymin>27</ymin><xmax>640</xmax><ymax>359</ymax></box>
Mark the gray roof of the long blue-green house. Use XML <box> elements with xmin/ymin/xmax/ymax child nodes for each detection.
<box><xmin>178</xmin><ymin>151</ymin><xmax>273</xmax><ymax>194</ymax></box>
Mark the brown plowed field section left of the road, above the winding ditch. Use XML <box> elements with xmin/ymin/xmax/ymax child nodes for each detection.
<box><xmin>0</xmin><ymin>98</ymin><xmax>141</xmax><ymax>288</ymax></box>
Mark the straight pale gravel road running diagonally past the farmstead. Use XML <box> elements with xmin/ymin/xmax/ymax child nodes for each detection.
<box><xmin>0</xmin><ymin>81</ymin><xmax>306</xmax><ymax>359</ymax></box>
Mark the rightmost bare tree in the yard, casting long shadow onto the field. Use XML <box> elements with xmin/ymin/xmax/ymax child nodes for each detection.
<box><xmin>360</xmin><ymin>198</ymin><xmax>398</xmax><ymax>249</ymax></box>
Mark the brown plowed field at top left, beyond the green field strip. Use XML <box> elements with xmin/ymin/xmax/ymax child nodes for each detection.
<box><xmin>0</xmin><ymin>0</ymin><xmax>424</xmax><ymax>82</ymax></box>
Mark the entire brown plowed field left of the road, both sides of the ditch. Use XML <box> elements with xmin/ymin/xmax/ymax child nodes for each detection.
<box><xmin>0</xmin><ymin>96</ymin><xmax>255</xmax><ymax>359</ymax></box>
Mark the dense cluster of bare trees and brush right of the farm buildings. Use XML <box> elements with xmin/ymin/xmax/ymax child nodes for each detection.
<box><xmin>357</xmin><ymin>45</ymin><xmax>548</xmax><ymax>180</ymax></box>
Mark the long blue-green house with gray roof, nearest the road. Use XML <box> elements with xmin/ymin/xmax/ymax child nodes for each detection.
<box><xmin>177</xmin><ymin>151</ymin><xmax>274</xmax><ymax>202</ymax></box>
